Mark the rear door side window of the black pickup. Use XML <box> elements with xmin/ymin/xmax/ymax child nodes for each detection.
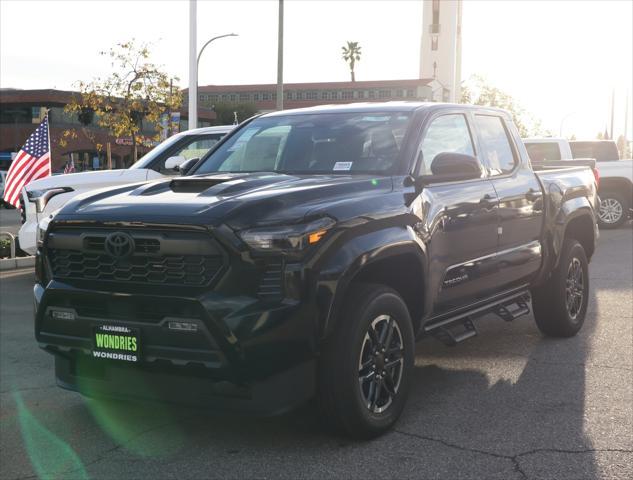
<box><xmin>475</xmin><ymin>115</ymin><xmax>516</xmax><ymax>175</ymax></box>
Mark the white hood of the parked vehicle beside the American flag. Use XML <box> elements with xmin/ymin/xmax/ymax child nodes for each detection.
<box><xmin>26</xmin><ymin>168</ymin><xmax>158</xmax><ymax>192</ymax></box>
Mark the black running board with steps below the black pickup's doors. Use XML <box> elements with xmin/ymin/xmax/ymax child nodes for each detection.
<box><xmin>424</xmin><ymin>290</ymin><xmax>531</xmax><ymax>346</ymax></box>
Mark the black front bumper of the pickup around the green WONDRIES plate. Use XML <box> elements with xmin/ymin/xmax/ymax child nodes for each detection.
<box><xmin>34</xmin><ymin>281</ymin><xmax>316</xmax><ymax>414</ymax></box>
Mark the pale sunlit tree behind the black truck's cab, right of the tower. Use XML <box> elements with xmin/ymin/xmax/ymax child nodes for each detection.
<box><xmin>460</xmin><ymin>75</ymin><xmax>551</xmax><ymax>138</ymax></box>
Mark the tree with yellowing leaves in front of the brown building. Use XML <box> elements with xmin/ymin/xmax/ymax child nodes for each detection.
<box><xmin>60</xmin><ymin>40</ymin><xmax>182</xmax><ymax>162</ymax></box>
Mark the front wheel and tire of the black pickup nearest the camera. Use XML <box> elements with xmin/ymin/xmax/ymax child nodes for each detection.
<box><xmin>317</xmin><ymin>284</ymin><xmax>415</xmax><ymax>439</ymax></box>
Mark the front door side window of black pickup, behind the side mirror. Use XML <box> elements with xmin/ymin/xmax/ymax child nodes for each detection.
<box><xmin>419</xmin><ymin>115</ymin><xmax>475</xmax><ymax>175</ymax></box>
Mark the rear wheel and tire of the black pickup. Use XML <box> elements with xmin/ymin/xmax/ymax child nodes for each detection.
<box><xmin>532</xmin><ymin>238</ymin><xmax>589</xmax><ymax>337</ymax></box>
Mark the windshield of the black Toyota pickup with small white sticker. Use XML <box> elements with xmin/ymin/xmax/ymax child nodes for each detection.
<box><xmin>193</xmin><ymin>112</ymin><xmax>410</xmax><ymax>174</ymax></box>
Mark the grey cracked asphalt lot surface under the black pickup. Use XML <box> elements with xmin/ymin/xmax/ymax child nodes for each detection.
<box><xmin>0</xmin><ymin>226</ymin><xmax>633</xmax><ymax>480</ymax></box>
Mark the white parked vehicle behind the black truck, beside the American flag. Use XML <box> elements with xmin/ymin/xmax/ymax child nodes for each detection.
<box><xmin>19</xmin><ymin>125</ymin><xmax>233</xmax><ymax>255</ymax></box>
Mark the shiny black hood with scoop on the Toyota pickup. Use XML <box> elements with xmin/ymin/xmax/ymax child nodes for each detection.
<box><xmin>58</xmin><ymin>173</ymin><xmax>401</xmax><ymax>229</ymax></box>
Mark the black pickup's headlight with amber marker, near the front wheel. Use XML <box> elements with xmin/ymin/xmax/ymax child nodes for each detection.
<box><xmin>239</xmin><ymin>217</ymin><xmax>335</xmax><ymax>253</ymax></box>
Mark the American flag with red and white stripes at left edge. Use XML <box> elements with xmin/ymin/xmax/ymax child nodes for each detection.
<box><xmin>4</xmin><ymin>115</ymin><xmax>51</xmax><ymax>207</ymax></box>
